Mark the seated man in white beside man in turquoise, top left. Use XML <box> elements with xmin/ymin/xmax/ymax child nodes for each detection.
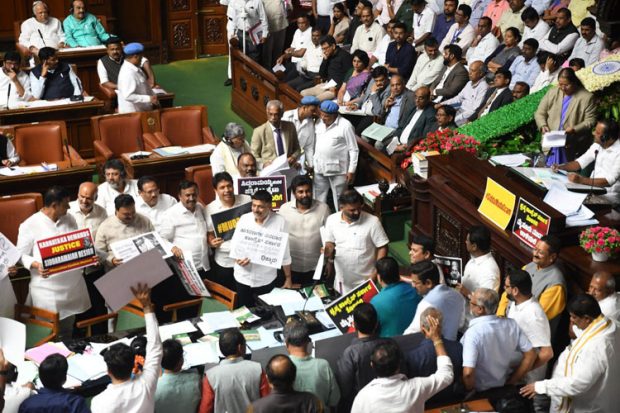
<box><xmin>18</xmin><ymin>1</ymin><xmax>65</xmax><ymax>56</ymax></box>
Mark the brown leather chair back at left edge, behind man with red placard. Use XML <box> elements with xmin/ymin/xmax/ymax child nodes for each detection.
<box><xmin>0</xmin><ymin>193</ymin><xmax>43</xmax><ymax>244</ymax></box>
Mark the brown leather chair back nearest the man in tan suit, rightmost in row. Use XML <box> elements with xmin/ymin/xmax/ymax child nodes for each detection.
<box><xmin>159</xmin><ymin>105</ymin><xmax>208</xmax><ymax>146</ymax></box>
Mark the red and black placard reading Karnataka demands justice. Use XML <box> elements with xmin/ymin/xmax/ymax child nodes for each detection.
<box><xmin>37</xmin><ymin>229</ymin><xmax>98</xmax><ymax>274</ymax></box>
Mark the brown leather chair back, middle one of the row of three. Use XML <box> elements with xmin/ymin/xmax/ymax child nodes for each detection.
<box><xmin>90</xmin><ymin>112</ymin><xmax>142</xmax><ymax>157</ymax></box>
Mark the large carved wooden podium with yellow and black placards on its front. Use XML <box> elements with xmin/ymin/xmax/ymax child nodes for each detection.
<box><xmin>409</xmin><ymin>151</ymin><xmax>620</xmax><ymax>292</ymax></box>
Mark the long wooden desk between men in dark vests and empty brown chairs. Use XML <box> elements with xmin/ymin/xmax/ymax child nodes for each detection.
<box><xmin>0</xmin><ymin>98</ymin><xmax>103</xmax><ymax>159</ymax></box>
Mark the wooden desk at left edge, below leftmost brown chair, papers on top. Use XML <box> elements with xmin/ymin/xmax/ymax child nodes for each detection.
<box><xmin>0</xmin><ymin>162</ymin><xmax>95</xmax><ymax>199</ymax></box>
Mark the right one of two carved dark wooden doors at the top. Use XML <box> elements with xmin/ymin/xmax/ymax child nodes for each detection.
<box><xmin>198</xmin><ymin>0</ymin><xmax>228</xmax><ymax>55</ymax></box>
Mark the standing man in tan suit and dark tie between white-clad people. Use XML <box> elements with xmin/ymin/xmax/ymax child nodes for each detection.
<box><xmin>252</xmin><ymin>100</ymin><xmax>301</xmax><ymax>168</ymax></box>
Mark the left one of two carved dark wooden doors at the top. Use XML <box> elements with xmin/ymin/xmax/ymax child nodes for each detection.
<box><xmin>166</xmin><ymin>0</ymin><xmax>198</xmax><ymax>60</ymax></box>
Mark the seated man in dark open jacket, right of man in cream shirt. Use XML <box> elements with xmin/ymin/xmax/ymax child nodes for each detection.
<box><xmin>431</xmin><ymin>44</ymin><xmax>469</xmax><ymax>103</ymax></box>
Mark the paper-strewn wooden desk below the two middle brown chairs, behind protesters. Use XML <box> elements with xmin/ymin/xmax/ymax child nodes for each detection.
<box><xmin>121</xmin><ymin>152</ymin><xmax>211</xmax><ymax>197</ymax></box>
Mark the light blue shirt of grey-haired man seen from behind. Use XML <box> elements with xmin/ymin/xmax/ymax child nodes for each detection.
<box><xmin>461</xmin><ymin>315</ymin><xmax>532</xmax><ymax>391</ymax></box>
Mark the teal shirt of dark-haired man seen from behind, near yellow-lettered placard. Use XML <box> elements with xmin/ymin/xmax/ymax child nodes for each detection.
<box><xmin>370</xmin><ymin>281</ymin><xmax>418</xmax><ymax>336</ymax></box>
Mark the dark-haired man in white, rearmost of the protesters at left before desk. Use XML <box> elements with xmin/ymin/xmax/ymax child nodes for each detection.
<box><xmin>96</xmin><ymin>159</ymin><xmax>139</xmax><ymax>215</ymax></box>
